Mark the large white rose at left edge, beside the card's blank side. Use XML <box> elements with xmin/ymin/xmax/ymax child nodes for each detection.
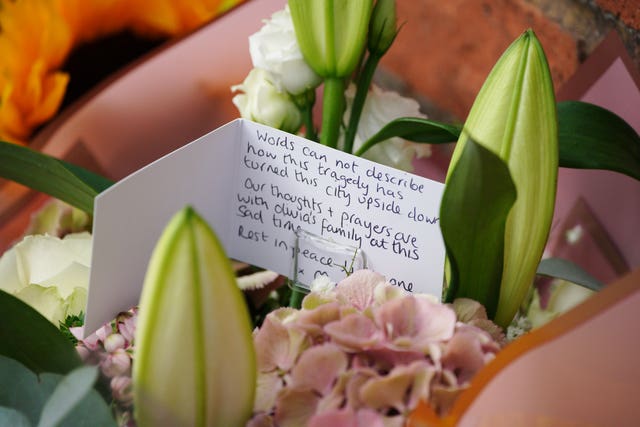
<box><xmin>0</xmin><ymin>233</ymin><xmax>91</xmax><ymax>326</ymax></box>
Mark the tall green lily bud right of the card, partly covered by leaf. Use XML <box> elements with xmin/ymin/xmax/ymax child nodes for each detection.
<box><xmin>449</xmin><ymin>30</ymin><xmax>558</xmax><ymax>326</ymax></box>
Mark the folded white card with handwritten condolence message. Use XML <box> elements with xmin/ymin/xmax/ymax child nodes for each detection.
<box><xmin>85</xmin><ymin>119</ymin><xmax>445</xmax><ymax>332</ymax></box>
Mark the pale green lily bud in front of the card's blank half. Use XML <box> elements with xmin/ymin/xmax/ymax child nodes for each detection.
<box><xmin>133</xmin><ymin>207</ymin><xmax>256</xmax><ymax>427</ymax></box>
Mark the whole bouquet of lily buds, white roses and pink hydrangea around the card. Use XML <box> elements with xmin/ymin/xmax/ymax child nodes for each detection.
<box><xmin>0</xmin><ymin>0</ymin><xmax>640</xmax><ymax>426</ymax></box>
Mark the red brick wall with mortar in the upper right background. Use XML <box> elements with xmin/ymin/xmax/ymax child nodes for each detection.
<box><xmin>376</xmin><ymin>0</ymin><xmax>640</xmax><ymax>120</ymax></box>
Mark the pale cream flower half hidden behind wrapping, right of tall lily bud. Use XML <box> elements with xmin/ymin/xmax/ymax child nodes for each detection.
<box><xmin>527</xmin><ymin>279</ymin><xmax>595</xmax><ymax>328</ymax></box>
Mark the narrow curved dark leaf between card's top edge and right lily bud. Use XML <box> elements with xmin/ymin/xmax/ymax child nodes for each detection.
<box><xmin>355</xmin><ymin>117</ymin><xmax>462</xmax><ymax>156</ymax></box>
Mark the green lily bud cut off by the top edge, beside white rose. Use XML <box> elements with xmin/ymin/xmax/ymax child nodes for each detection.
<box><xmin>289</xmin><ymin>0</ymin><xmax>373</xmax><ymax>78</ymax></box>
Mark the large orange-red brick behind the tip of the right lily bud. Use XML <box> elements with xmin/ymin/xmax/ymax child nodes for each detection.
<box><xmin>382</xmin><ymin>0</ymin><xmax>578</xmax><ymax>120</ymax></box>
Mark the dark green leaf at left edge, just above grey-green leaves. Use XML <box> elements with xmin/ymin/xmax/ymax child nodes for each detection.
<box><xmin>0</xmin><ymin>291</ymin><xmax>81</xmax><ymax>374</ymax></box>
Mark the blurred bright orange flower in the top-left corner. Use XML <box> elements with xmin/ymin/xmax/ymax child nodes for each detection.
<box><xmin>0</xmin><ymin>0</ymin><xmax>248</xmax><ymax>143</ymax></box>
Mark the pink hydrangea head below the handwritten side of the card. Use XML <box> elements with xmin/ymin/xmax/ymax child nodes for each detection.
<box><xmin>248</xmin><ymin>270</ymin><xmax>501</xmax><ymax>427</ymax></box>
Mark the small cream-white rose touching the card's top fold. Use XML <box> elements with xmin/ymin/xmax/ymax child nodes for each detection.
<box><xmin>231</xmin><ymin>68</ymin><xmax>302</xmax><ymax>133</ymax></box>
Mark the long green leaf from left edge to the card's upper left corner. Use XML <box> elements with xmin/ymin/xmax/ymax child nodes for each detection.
<box><xmin>0</xmin><ymin>141</ymin><xmax>113</xmax><ymax>213</ymax></box>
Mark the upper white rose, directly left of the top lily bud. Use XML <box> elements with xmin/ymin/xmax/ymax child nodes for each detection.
<box><xmin>249</xmin><ymin>6</ymin><xmax>322</xmax><ymax>95</ymax></box>
